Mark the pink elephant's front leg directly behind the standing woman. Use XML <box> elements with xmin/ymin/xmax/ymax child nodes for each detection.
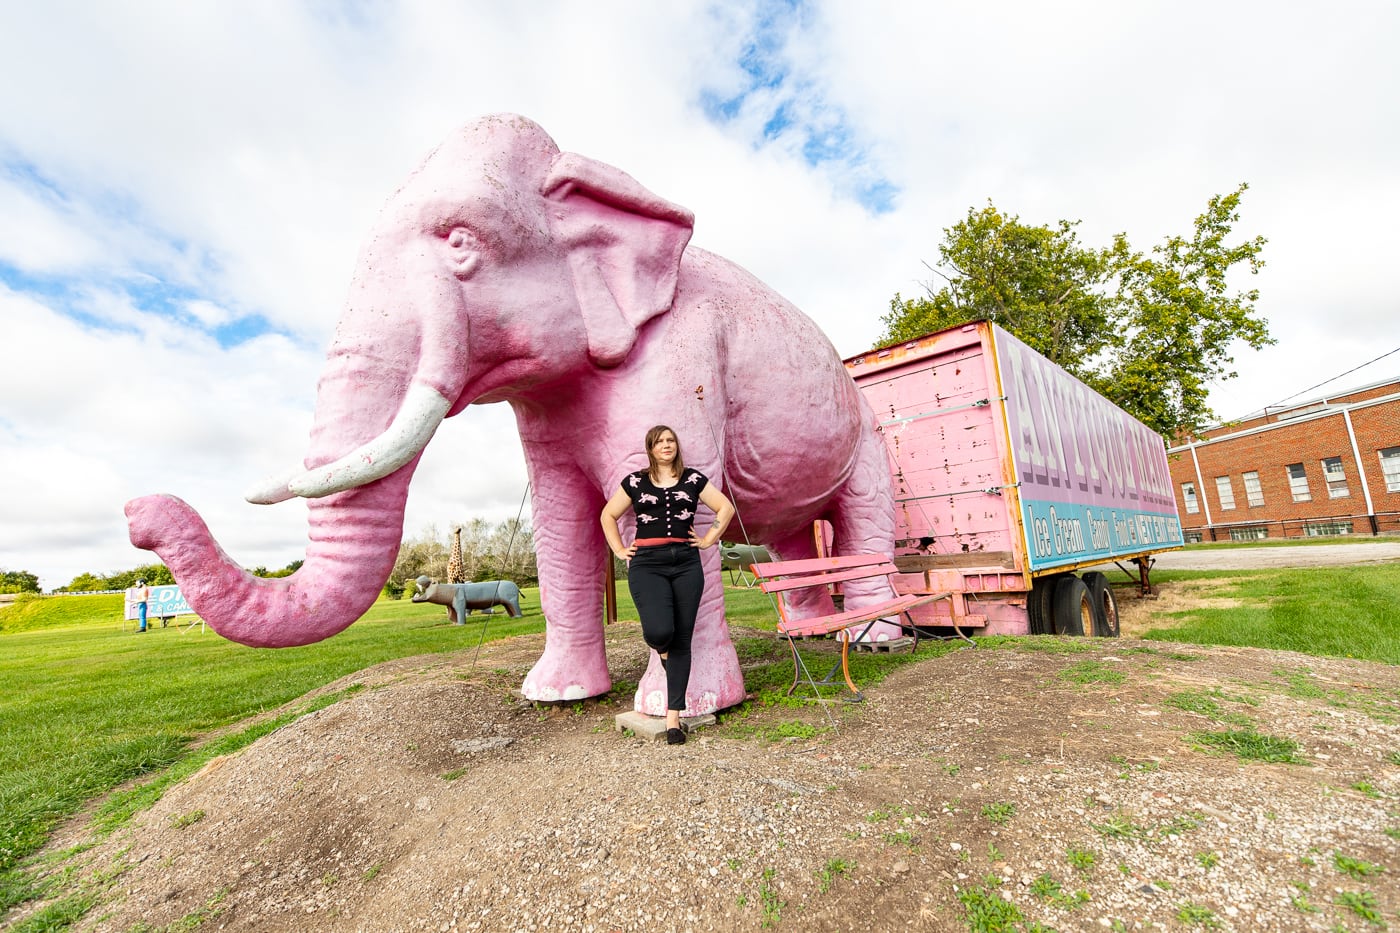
<box><xmin>636</xmin><ymin>537</ymin><xmax>745</xmax><ymax>716</ymax></box>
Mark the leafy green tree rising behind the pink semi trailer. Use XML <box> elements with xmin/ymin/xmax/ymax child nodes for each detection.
<box><xmin>883</xmin><ymin>185</ymin><xmax>1274</xmax><ymax>440</ymax></box>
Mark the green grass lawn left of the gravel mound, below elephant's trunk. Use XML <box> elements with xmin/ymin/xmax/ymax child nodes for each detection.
<box><xmin>0</xmin><ymin>591</ymin><xmax>543</xmax><ymax>909</ymax></box>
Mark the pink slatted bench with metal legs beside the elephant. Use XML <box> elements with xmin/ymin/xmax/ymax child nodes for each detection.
<box><xmin>749</xmin><ymin>553</ymin><xmax>948</xmax><ymax>699</ymax></box>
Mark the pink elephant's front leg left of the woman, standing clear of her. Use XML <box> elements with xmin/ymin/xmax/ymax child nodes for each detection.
<box><xmin>521</xmin><ymin>462</ymin><xmax>612</xmax><ymax>700</ymax></box>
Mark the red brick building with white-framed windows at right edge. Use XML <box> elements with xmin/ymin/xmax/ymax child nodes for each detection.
<box><xmin>1168</xmin><ymin>380</ymin><xmax>1400</xmax><ymax>541</ymax></box>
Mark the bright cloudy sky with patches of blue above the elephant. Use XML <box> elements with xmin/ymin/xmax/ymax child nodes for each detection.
<box><xmin>0</xmin><ymin>0</ymin><xmax>1400</xmax><ymax>588</ymax></box>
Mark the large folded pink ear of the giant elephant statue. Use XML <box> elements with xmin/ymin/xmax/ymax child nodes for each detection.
<box><xmin>542</xmin><ymin>153</ymin><xmax>694</xmax><ymax>367</ymax></box>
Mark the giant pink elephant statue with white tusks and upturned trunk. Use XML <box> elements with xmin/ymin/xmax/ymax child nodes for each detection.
<box><xmin>126</xmin><ymin>115</ymin><xmax>897</xmax><ymax>716</ymax></box>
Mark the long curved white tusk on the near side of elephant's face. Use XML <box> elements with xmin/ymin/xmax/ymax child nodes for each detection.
<box><xmin>261</xmin><ymin>382</ymin><xmax>452</xmax><ymax>503</ymax></box>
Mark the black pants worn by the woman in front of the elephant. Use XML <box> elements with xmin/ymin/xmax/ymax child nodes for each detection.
<box><xmin>627</xmin><ymin>544</ymin><xmax>704</xmax><ymax>710</ymax></box>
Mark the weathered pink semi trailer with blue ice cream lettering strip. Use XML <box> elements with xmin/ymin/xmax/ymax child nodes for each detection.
<box><xmin>846</xmin><ymin>321</ymin><xmax>1184</xmax><ymax>636</ymax></box>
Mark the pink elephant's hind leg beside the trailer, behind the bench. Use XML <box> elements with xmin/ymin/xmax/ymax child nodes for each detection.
<box><xmin>830</xmin><ymin>431</ymin><xmax>902</xmax><ymax>642</ymax></box>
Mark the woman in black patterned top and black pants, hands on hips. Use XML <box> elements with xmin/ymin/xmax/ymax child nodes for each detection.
<box><xmin>602</xmin><ymin>424</ymin><xmax>734</xmax><ymax>745</ymax></box>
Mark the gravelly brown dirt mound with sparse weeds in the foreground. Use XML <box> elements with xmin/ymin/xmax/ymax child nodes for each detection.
<box><xmin>13</xmin><ymin>610</ymin><xmax>1400</xmax><ymax>930</ymax></box>
